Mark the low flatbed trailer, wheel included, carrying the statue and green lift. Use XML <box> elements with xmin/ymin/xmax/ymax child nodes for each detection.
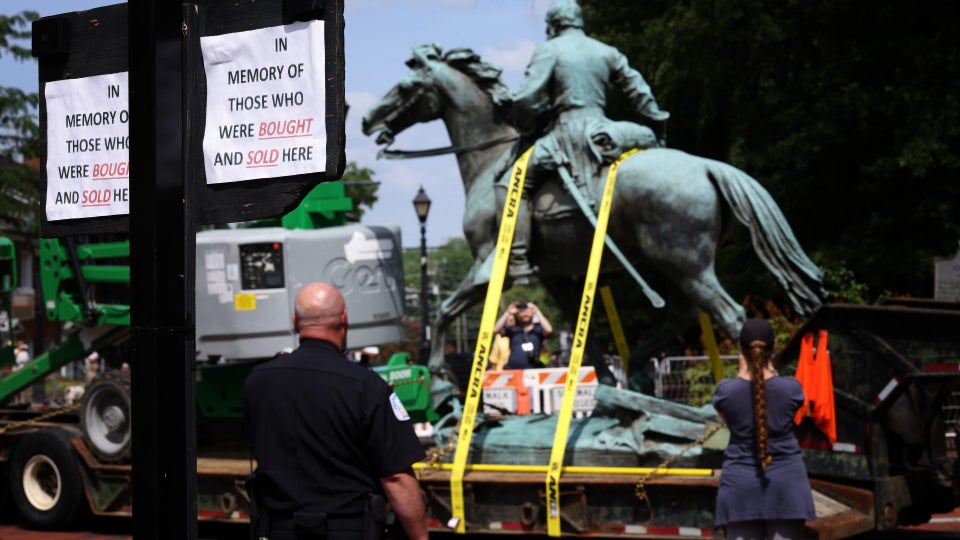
<box><xmin>0</xmin><ymin>410</ymin><xmax>875</xmax><ymax>540</ymax></box>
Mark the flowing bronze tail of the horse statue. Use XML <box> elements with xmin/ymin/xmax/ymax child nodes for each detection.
<box><xmin>707</xmin><ymin>160</ymin><xmax>826</xmax><ymax>316</ymax></box>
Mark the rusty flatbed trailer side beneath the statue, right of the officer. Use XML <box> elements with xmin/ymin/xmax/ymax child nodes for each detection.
<box><xmin>410</xmin><ymin>464</ymin><xmax>875</xmax><ymax>540</ymax></box>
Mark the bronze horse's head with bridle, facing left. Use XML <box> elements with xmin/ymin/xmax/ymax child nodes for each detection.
<box><xmin>363</xmin><ymin>45</ymin><xmax>443</xmax><ymax>144</ymax></box>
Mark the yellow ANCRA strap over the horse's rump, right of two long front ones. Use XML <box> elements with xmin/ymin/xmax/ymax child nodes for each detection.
<box><xmin>546</xmin><ymin>149</ymin><xmax>640</xmax><ymax>537</ymax></box>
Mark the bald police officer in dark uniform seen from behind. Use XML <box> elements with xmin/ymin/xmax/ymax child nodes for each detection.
<box><xmin>243</xmin><ymin>283</ymin><xmax>427</xmax><ymax>540</ymax></box>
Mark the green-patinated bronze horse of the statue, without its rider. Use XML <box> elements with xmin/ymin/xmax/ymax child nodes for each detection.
<box><xmin>363</xmin><ymin>45</ymin><xmax>824</xmax><ymax>388</ymax></box>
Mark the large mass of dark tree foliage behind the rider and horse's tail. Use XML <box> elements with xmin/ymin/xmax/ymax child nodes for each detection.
<box><xmin>580</xmin><ymin>0</ymin><xmax>960</xmax><ymax>304</ymax></box>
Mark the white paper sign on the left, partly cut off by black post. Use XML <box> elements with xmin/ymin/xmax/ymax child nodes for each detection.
<box><xmin>44</xmin><ymin>72</ymin><xmax>130</xmax><ymax>221</ymax></box>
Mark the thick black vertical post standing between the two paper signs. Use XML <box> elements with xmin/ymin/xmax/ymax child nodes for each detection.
<box><xmin>127</xmin><ymin>0</ymin><xmax>197</xmax><ymax>540</ymax></box>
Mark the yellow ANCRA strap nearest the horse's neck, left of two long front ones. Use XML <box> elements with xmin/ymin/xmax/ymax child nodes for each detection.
<box><xmin>447</xmin><ymin>147</ymin><xmax>533</xmax><ymax>534</ymax></box>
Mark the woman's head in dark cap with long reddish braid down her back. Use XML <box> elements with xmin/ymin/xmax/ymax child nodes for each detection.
<box><xmin>739</xmin><ymin>319</ymin><xmax>774</xmax><ymax>469</ymax></box>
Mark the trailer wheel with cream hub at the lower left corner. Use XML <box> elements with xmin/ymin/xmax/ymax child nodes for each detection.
<box><xmin>9</xmin><ymin>429</ymin><xmax>83</xmax><ymax>529</ymax></box>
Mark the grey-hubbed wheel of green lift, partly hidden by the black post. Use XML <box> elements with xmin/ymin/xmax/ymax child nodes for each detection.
<box><xmin>80</xmin><ymin>371</ymin><xmax>132</xmax><ymax>462</ymax></box>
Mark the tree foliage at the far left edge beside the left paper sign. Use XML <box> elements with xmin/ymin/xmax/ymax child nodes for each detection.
<box><xmin>0</xmin><ymin>11</ymin><xmax>40</xmax><ymax>235</ymax></box>
